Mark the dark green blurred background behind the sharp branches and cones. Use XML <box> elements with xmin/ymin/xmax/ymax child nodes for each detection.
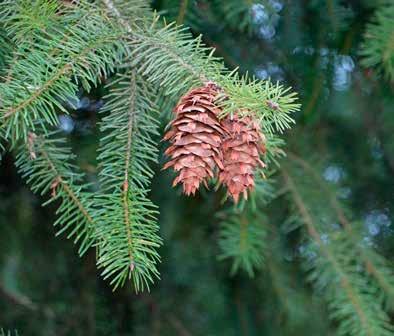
<box><xmin>0</xmin><ymin>0</ymin><xmax>394</xmax><ymax>336</ymax></box>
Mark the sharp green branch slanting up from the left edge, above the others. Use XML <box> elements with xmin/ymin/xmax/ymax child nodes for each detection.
<box><xmin>0</xmin><ymin>0</ymin><xmax>123</xmax><ymax>142</ymax></box>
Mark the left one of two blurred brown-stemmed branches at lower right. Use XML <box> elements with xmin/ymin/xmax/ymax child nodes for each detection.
<box><xmin>282</xmin><ymin>170</ymin><xmax>394</xmax><ymax>336</ymax></box>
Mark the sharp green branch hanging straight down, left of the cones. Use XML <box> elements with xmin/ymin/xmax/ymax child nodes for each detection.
<box><xmin>97</xmin><ymin>71</ymin><xmax>161</xmax><ymax>291</ymax></box>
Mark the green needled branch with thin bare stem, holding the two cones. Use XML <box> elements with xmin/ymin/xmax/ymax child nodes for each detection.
<box><xmin>105</xmin><ymin>1</ymin><xmax>300</xmax><ymax>133</ymax></box>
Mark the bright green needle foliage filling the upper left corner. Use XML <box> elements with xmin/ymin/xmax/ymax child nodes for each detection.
<box><xmin>0</xmin><ymin>0</ymin><xmax>122</xmax><ymax>143</ymax></box>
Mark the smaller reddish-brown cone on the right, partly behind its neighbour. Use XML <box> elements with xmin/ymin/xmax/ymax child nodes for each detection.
<box><xmin>219</xmin><ymin>116</ymin><xmax>265</xmax><ymax>203</ymax></box>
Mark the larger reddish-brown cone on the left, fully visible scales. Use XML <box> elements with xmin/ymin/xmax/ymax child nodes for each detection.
<box><xmin>163</xmin><ymin>83</ymin><xmax>224</xmax><ymax>195</ymax></box>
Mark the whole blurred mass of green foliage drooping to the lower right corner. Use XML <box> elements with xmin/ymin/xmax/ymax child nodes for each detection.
<box><xmin>283</xmin><ymin>156</ymin><xmax>394</xmax><ymax>335</ymax></box>
